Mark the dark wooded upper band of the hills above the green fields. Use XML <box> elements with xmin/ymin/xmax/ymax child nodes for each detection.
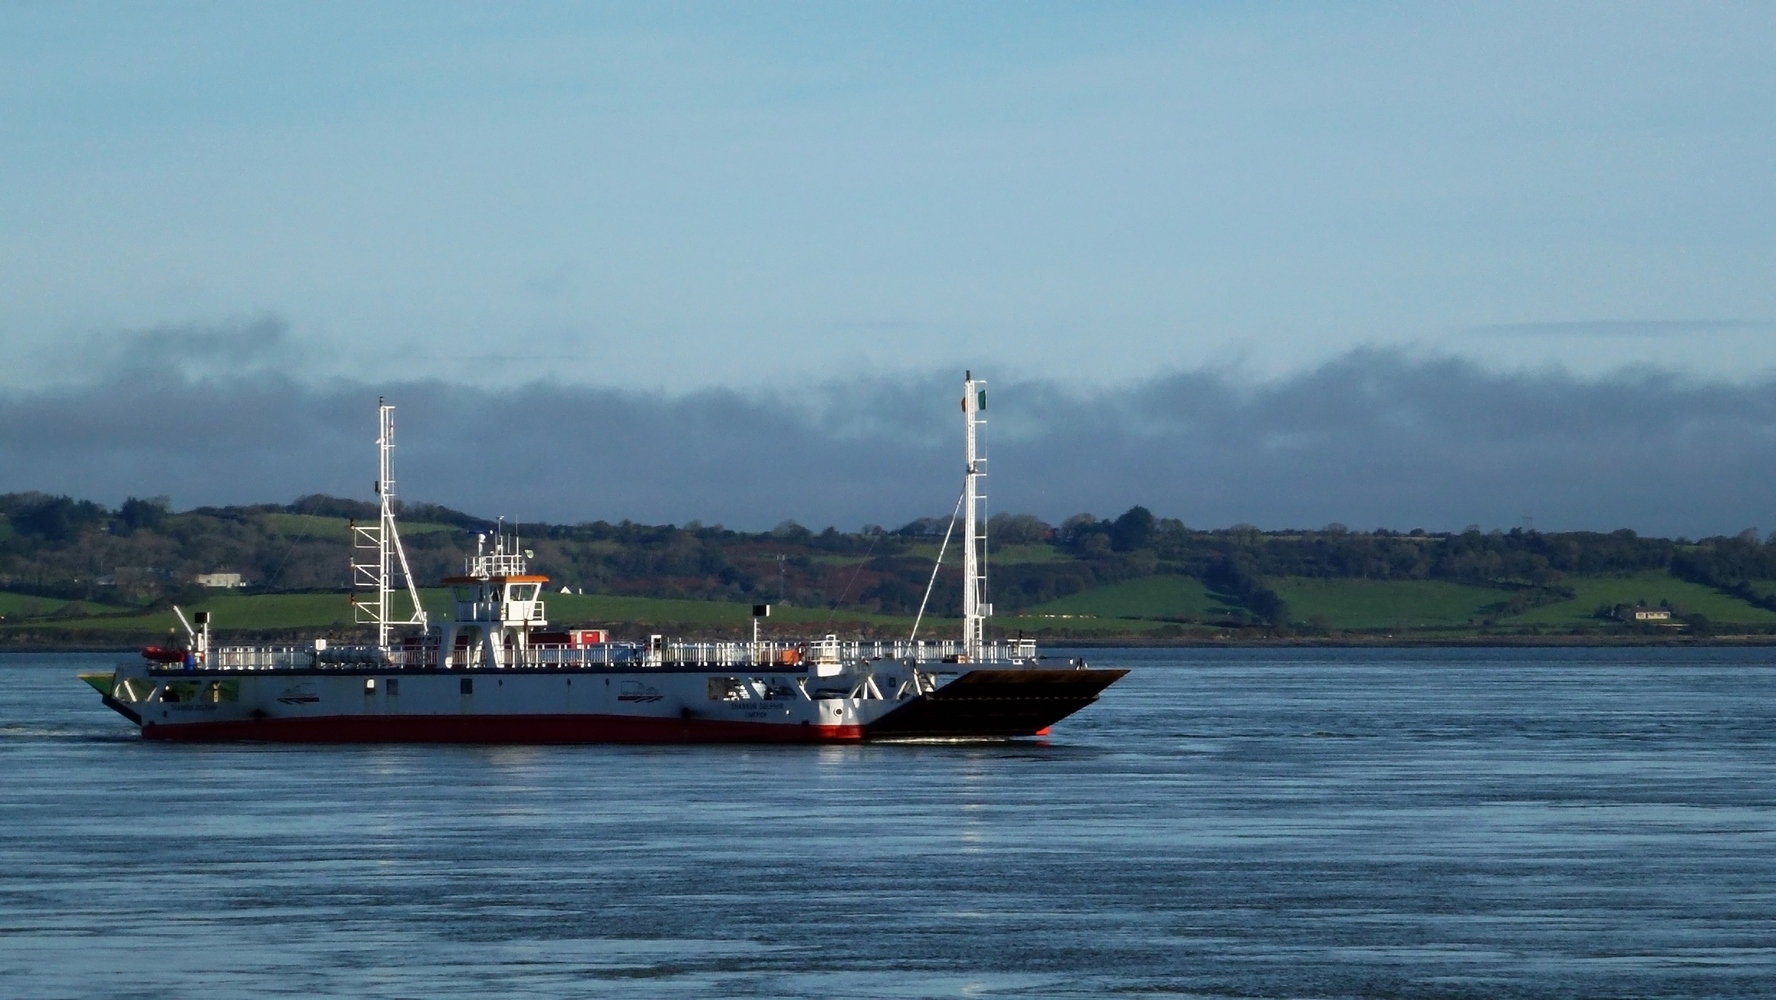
<box><xmin>0</xmin><ymin>494</ymin><xmax>1776</xmax><ymax>623</ymax></box>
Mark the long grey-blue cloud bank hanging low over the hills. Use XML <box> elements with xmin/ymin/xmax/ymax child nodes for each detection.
<box><xmin>0</xmin><ymin>329</ymin><xmax>1776</xmax><ymax>536</ymax></box>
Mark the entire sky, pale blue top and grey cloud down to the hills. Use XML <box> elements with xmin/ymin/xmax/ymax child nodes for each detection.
<box><xmin>0</xmin><ymin>2</ymin><xmax>1776</xmax><ymax>535</ymax></box>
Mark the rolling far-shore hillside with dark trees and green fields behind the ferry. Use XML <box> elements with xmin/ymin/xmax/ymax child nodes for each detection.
<box><xmin>10</xmin><ymin>494</ymin><xmax>1776</xmax><ymax>645</ymax></box>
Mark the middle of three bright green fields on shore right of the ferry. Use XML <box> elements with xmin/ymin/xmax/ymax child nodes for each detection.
<box><xmin>1270</xmin><ymin>577</ymin><xmax>1511</xmax><ymax>629</ymax></box>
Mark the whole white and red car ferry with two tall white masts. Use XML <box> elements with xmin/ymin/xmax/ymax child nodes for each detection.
<box><xmin>82</xmin><ymin>373</ymin><xmax>1128</xmax><ymax>744</ymax></box>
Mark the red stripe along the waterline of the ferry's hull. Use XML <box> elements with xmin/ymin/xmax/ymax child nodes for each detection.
<box><xmin>142</xmin><ymin>716</ymin><xmax>863</xmax><ymax>742</ymax></box>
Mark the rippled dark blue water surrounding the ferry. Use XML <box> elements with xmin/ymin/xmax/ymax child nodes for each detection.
<box><xmin>0</xmin><ymin>650</ymin><xmax>1776</xmax><ymax>998</ymax></box>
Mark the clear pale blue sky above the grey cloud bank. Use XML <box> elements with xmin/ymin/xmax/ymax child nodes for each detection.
<box><xmin>0</xmin><ymin>4</ymin><xmax>1776</xmax><ymax>385</ymax></box>
